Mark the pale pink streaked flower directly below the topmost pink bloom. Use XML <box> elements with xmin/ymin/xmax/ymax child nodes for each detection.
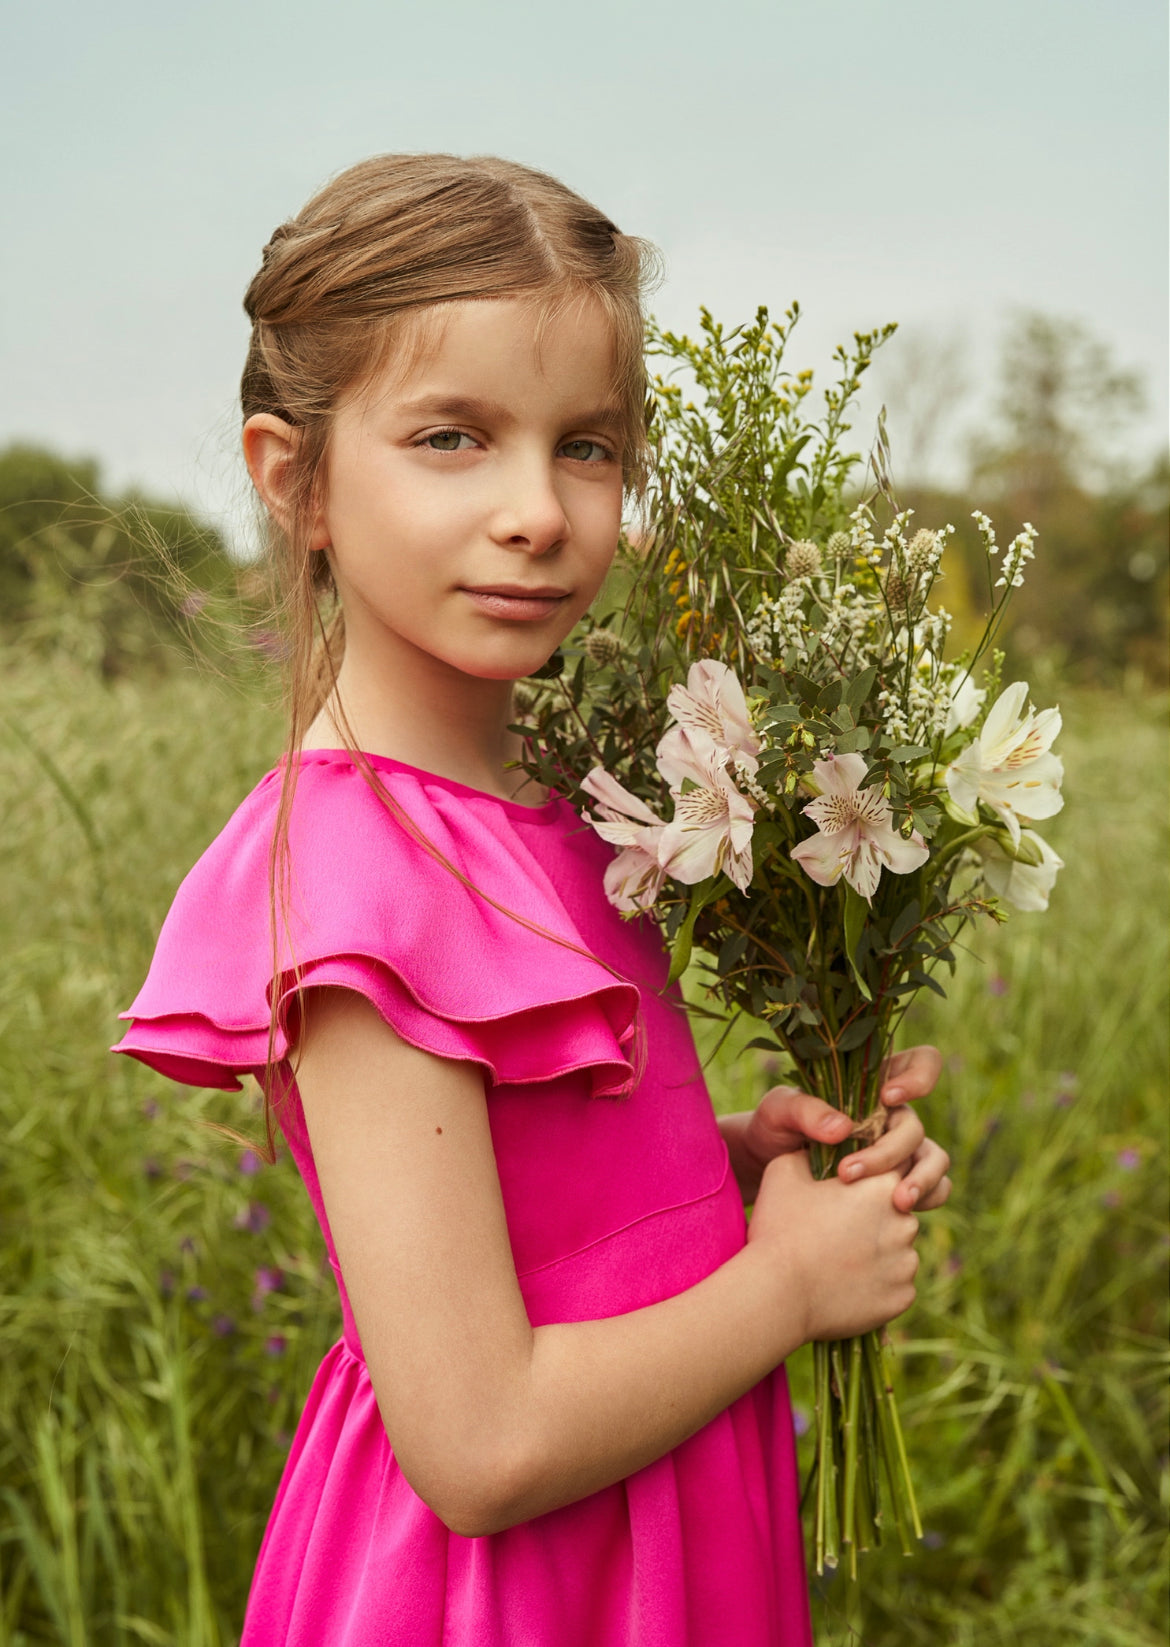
<box><xmin>658</xmin><ymin>726</ymin><xmax>756</xmax><ymax>893</ymax></box>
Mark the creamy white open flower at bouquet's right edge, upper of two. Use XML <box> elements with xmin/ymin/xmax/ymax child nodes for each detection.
<box><xmin>946</xmin><ymin>680</ymin><xmax>1065</xmax><ymax>843</ymax></box>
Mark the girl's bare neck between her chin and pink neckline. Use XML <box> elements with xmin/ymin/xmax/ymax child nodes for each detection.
<box><xmin>302</xmin><ymin>619</ymin><xmax>542</xmax><ymax>804</ymax></box>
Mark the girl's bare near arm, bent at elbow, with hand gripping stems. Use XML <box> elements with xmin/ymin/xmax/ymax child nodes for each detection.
<box><xmin>297</xmin><ymin>990</ymin><xmax>916</xmax><ymax>1535</ymax></box>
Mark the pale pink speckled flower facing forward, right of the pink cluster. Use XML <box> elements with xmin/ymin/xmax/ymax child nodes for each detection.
<box><xmin>791</xmin><ymin>754</ymin><xmax>929</xmax><ymax>899</ymax></box>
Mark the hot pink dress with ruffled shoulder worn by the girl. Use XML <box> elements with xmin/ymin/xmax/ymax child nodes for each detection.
<box><xmin>117</xmin><ymin>749</ymin><xmax>812</xmax><ymax>1647</ymax></box>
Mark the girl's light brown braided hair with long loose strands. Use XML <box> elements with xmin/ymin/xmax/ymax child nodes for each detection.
<box><xmin>241</xmin><ymin>155</ymin><xmax>661</xmax><ymax>1159</ymax></box>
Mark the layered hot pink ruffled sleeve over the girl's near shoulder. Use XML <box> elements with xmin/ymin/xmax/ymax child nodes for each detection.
<box><xmin>114</xmin><ymin>754</ymin><xmax>639</xmax><ymax>1097</ymax></box>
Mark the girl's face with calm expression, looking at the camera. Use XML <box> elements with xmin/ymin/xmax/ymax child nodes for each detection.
<box><xmin>316</xmin><ymin>298</ymin><xmax>623</xmax><ymax>680</ymax></box>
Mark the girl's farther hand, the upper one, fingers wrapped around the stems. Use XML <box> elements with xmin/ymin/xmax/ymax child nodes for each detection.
<box><xmin>718</xmin><ymin>1046</ymin><xmax>951</xmax><ymax>1212</ymax></box>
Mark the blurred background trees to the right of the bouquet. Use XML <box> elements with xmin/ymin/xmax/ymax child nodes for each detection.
<box><xmin>892</xmin><ymin>311</ymin><xmax>1170</xmax><ymax>685</ymax></box>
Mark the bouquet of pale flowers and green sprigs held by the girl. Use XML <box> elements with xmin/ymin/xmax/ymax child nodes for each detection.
<box><xmin>517</xmin><ymin>306</ymin><xmax>1063</xmax><ymax>1573</ymax></box>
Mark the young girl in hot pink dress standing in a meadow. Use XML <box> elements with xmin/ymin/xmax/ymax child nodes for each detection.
<box><xmin>119</xmin><ymin>155</ymin><xmax>949</xmax><ymax>1647</ymax></box>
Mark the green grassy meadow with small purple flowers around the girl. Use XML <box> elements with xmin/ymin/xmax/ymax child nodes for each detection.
<box><xmin>0</xmin><ymin>648</ymin><xmax>1168</xmax><ymax>1647</ymax></box>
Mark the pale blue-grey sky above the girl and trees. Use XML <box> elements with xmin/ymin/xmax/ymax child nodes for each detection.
<box><xmin>0</xmin><ymin>0</ymin><xmax>1167</xmax><ymax>546</ymax></box>
